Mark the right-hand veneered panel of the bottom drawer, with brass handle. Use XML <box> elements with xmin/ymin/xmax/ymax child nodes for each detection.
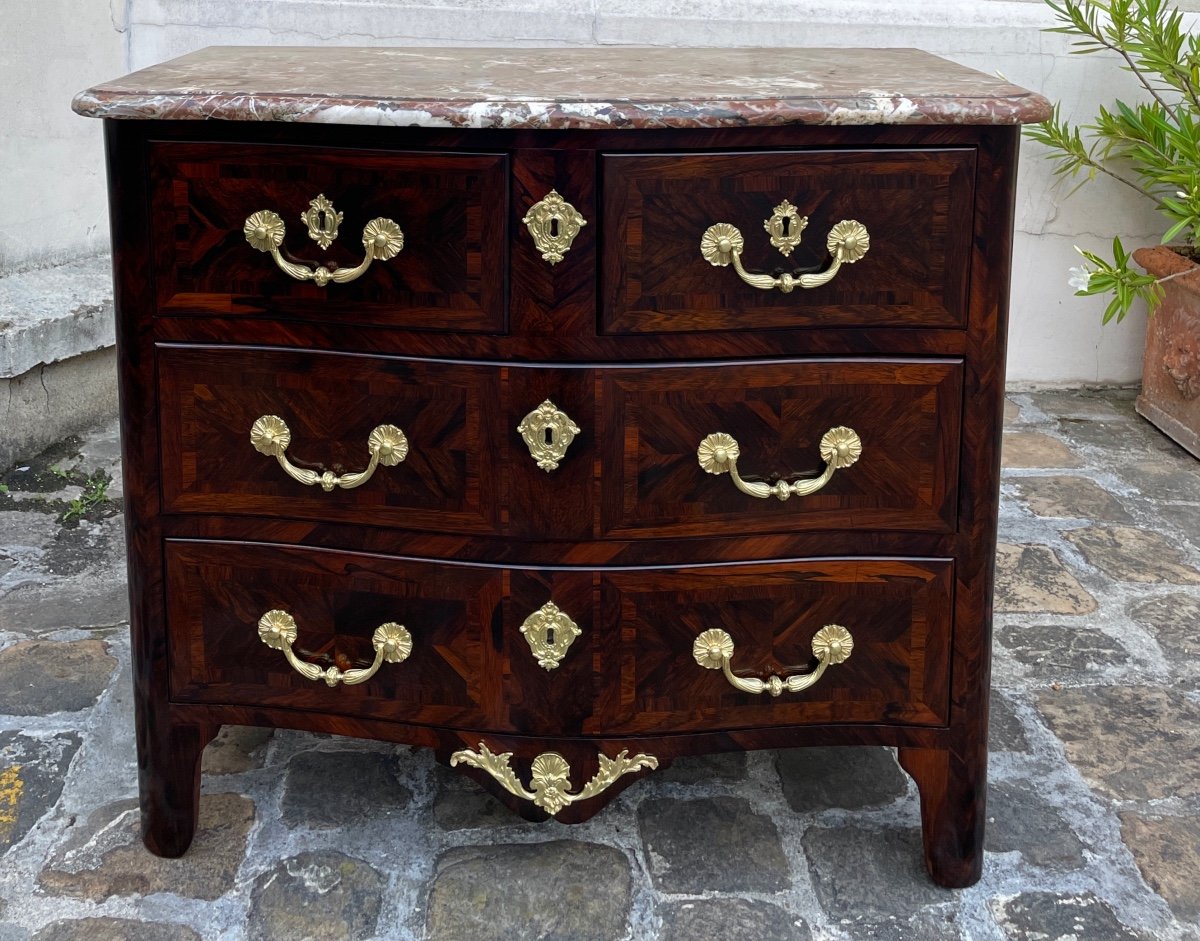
<box><xmin>598</xmin><ymin>559</ymin><xmax>953</xmax><ymax>735</ymax></box>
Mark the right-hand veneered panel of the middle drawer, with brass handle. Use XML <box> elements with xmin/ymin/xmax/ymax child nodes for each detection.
<box><xmin>599</xmin><ymin>361</ymin><xmax>962</xmax><ymax>537</ymax></box>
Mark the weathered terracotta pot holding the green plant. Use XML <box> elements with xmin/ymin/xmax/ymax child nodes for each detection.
<box><xmin>1133</xmin><ymin>247</ymin><xmax>1200</xmax><ymax>457</ymax></box>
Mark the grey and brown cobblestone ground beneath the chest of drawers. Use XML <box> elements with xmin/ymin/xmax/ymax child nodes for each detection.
<box><xmin>0</xmin><ymin>391</ymin><xmax>1200</xmax><ymax>941</ymax></box>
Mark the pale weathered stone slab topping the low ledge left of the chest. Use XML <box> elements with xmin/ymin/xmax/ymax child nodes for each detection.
<box><xmin>0</xmin><ymin>254</ymin><xmax>116</xmax><ymax>379</ymax></box>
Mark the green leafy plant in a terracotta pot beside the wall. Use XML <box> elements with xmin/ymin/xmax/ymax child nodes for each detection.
<box><xmin>1027</xmin><ymin>0</ymin><xmax>1200</xmax><ymax>457</ymax></box>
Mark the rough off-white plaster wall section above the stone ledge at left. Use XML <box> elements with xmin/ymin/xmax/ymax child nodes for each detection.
<box><xmin>0</xmin><ymin>0</ymin><xmax>126</xmax><ymax>276</ymax></box>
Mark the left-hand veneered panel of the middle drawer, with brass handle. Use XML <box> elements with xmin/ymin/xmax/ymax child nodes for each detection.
<box><xmin>158</xmin><ymin>346</ymin><xmax>506</xmax><ymax>533</ymax></box>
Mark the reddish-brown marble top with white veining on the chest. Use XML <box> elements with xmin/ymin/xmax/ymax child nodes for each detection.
<box><xmin>73</xmin><ymin>46</ymin><xmax>1050</xmax><ymax>128</ymax></box>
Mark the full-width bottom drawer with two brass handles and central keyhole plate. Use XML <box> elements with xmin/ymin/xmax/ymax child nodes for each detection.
<box><xmin>164</xmin><ymin>540</ymin><xmax>953</xmax><ymax>736</ymax></box>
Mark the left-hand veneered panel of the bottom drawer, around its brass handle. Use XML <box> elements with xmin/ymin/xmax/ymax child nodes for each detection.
<box><xmin>166</xmin><ymin>540</ymin><xmax>506</xmax><ymax>727</ymax></box>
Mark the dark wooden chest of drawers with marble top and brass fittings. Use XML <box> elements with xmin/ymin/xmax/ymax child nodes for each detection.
<box><xmin>76</xmin><ymin>48</ymin><xmax>1045</xmax><ymax>886</ymax></box>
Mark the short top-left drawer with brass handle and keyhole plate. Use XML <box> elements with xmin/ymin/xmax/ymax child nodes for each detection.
<box><xmin>150</xmin><ymin>143</ymin><xmax>508</xmax><ymax>332</ymax></box>
